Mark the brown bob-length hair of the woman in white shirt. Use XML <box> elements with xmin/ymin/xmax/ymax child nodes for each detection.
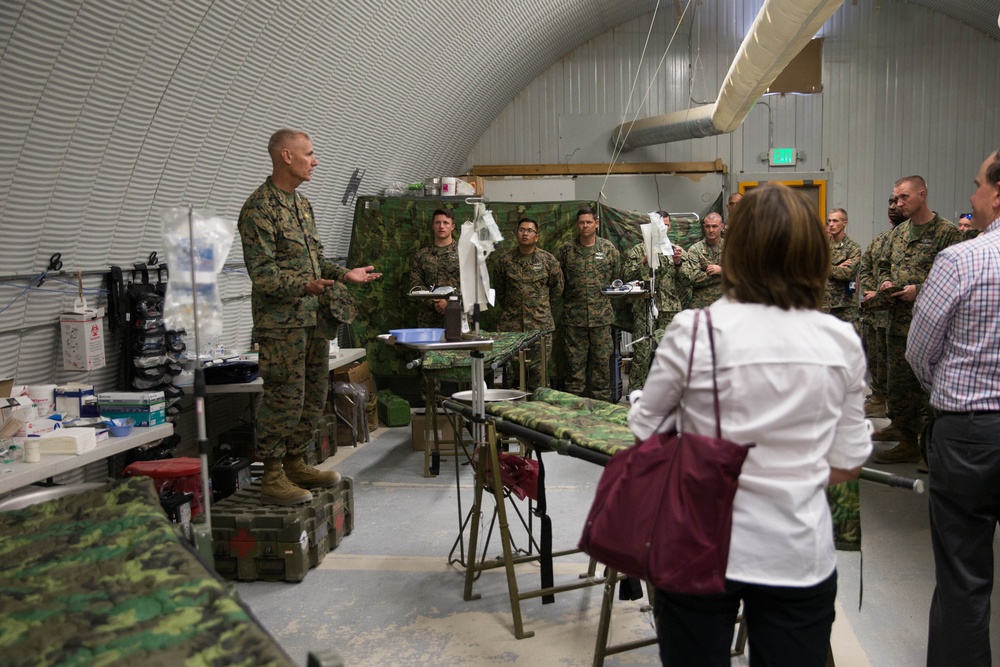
<box><xmin>722</xmin><ymin>185</ymin><xmax>831</xmax><ymax>310</ymax></box>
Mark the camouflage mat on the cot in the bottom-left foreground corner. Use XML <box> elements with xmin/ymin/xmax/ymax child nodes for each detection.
<box><xmin>0</xmin><ymin>477</ymin><xmax>295</xmax><ymax>667</ymax></box>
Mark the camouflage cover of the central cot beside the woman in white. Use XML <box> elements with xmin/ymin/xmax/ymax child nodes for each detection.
<box><xmin>478</xmin><ymin>388</ymin><xmax>861</xmax><ymax>551</ymax></box>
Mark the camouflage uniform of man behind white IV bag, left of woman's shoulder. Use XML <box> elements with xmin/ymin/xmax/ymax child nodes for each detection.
<box><xmin>622</xmin><ymin>243</ymin><xmax>691</xmax><ymax>391</ymax></box>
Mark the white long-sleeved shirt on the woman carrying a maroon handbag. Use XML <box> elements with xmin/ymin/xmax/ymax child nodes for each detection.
<box><xmin>629</xmin><ymin>297</ymin><xmax>872</xmax><ymax>586</ymax></box>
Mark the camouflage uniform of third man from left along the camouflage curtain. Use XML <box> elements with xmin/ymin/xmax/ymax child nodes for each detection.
<box><xmin>556</xmin><ymin>237</ymin><xmax>621</xmax><ymax>401</ymax></box>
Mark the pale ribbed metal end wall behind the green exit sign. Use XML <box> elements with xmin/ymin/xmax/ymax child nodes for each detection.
<box><xmin>469</xmin><ymin>0</ymin><xmax>1000</xmax><ymax>256</ymax></box>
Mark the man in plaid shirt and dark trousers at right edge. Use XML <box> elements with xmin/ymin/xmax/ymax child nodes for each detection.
<box><xmin>906</xmin><ymin>151</ymin><xmax>1000</xmax><ymax>667</ymax></box>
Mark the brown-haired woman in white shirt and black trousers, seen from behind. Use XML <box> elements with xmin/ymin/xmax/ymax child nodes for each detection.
<box><xmin>629</xmin><ymin>185</ymin><xmax>872</xmax><ymax>667</ymax></box>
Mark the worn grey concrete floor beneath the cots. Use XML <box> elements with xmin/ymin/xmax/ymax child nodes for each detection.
<box><xmin>237</xmin><ymin>420</ymin><xmax>1000</xmax><ymax>667</ymax></box>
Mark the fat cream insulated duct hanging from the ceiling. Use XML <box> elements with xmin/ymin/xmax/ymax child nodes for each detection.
<box><xmin>611</xmin><ymin>0</ymin><xmax>844</xmax><ymax>152</ymax></box>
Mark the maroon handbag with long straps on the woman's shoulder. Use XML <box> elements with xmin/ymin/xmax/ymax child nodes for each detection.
<box><xmin>579</xmin><ymin>308</ymin><xmax>754</xmax><ymax>595</ymax></box>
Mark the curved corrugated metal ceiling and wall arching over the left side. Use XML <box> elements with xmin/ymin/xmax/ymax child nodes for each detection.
<box><xmin>0</xmin><ymin>0</ymin><xmax>1000</xmax><ymax>380</ymax></box>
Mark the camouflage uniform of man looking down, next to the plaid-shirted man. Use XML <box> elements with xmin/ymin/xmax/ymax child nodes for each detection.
<box><xmin>875</xmin><ymin>213</ymin><xmax>962</xmax><ymax>442</ymax></box>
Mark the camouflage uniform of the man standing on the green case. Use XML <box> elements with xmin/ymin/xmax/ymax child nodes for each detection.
<box><xmin>239</xmin><ymin>177</ymin><xmax>347</xmax><ymax>459</ymax></box>
